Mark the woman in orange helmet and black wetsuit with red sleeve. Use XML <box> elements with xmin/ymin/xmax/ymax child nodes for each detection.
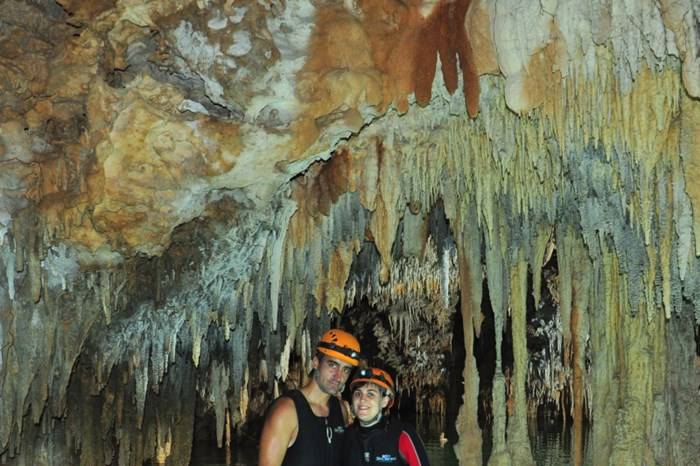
<box><xmin>341</xmin><ymin>368</ymin><xmax>429</xmax><ymax>466</ymax></box>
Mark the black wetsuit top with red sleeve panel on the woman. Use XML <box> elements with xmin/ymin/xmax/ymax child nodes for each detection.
<box><xmin>341</xmin><ymin>418</ymin><xmax>429</xmax><ymax>466</ymax></box>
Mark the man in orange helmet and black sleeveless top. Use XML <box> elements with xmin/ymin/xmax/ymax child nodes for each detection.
<box><xmin>258</xmin><ymin>329</ymin><xmax>360</xmax><ymax>466</ymax></box>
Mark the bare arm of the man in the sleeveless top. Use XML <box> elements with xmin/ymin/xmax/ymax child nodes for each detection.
<box><xmin>258</xmin><ymin>397</ymin><xmax>299</xmax><ymax>466</ymax></box>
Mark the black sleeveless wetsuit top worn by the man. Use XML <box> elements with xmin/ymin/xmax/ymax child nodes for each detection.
<box><xmin>282</xmin><ymin>390</ymin><xmax>345</xmax><ymax>466</ymax></box>
